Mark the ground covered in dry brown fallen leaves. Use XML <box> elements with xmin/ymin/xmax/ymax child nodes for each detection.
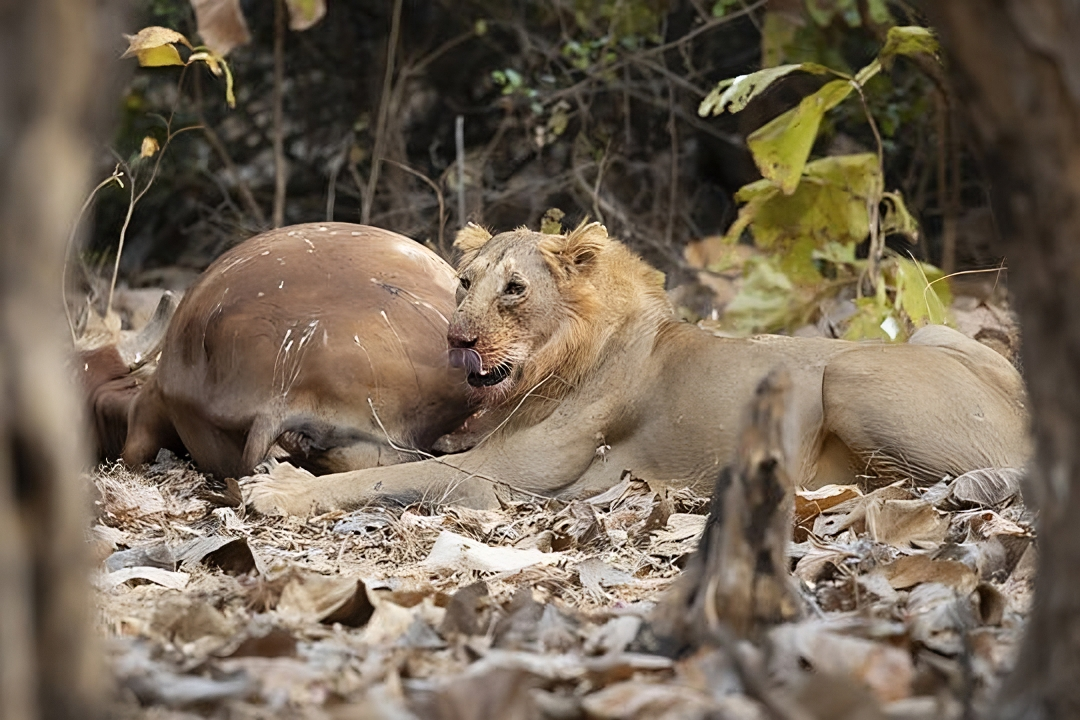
<box><xmin>91</xmin><ymin>446</ymin><xmax>1035</xmax><ymax>720</ymax></box>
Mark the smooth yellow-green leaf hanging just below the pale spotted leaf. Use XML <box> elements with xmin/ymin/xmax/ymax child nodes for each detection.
<box><xmin>746</xmin><ymin>80</ymin><xmax>852</xmax><ymax>195</ymax></box>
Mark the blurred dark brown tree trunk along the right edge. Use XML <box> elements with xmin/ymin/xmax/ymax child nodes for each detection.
<box><xmin>923</xmin><ymin>0</ymin><xmax>1080</xmax><ymax>719</ymax></box>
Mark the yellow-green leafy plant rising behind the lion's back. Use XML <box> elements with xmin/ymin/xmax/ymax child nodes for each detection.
<box><xmin>699</xmin><ymin>26</ymin><xmax>949</xmax><ymax>340</ymax></box>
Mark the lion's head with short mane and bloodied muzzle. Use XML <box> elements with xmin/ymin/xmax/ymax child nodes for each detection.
<box><xmin>448</xmin><ymin>222</ymin><xmax>672</xmax><ymax>416</ymax></box>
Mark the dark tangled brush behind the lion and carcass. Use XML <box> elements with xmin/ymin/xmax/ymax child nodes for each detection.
<box><xmin>83</xmin><ymin>0</ymin><xmax>997</xmax><ymax>293</ymax></box>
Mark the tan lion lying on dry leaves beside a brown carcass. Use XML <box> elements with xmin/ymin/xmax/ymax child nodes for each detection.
<box><xmin>245</xmin><ymin>222</ymin><xmax>1030</xmax><ymax>514</ymax></box>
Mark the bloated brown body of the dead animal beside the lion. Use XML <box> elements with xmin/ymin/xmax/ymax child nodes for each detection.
<box><xmin>113</xmin><ymin>222</ymin><xmax>472</xmax><ymax>477</ymax></box>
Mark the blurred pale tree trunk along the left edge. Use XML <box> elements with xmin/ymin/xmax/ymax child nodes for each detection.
<box><xmin>0</xmin><ymin>0</ymin><xmax>114</xmax><ymax>720</ymax></box>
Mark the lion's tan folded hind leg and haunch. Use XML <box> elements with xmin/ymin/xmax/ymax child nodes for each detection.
<box><xmin>822</xmin><ymin>326</ymin><xmax>1028</xmax><ymax>484</ymax></box>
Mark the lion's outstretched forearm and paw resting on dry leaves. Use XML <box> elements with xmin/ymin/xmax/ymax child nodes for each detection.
<box><xmin>243</xmin><ymin>452</ymin><xmax>498</xmax><ymax>515</ymax></box>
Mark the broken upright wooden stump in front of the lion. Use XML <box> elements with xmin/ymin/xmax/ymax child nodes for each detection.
<box><xmin>643</xmin><ymin>370</ymin><xmax>800</xmax><ymax>653</ymax></box>
